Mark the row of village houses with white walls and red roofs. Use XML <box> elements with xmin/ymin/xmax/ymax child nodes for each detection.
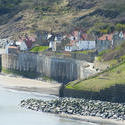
<box><xmin>0</xmin><ymin>30</ymin><xmax>125</xmax><ymax>54</ymax></box>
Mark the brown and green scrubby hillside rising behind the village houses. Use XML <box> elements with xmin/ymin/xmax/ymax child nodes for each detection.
<box><xmin>0</xmin><ymin>0</ymin><xmax>125</xmax><ymax>37</ymax></box>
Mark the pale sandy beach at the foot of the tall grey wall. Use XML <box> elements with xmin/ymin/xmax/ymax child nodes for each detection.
<box><xmin>0</xmin><ymin>75</ymin><xmax>61</xmax><ymax>95</ymax></box>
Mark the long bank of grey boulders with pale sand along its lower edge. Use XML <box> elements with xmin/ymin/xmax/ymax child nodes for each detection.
<box><xmin>20</xmin><ymin>98</ymin><xmax>125</xmax><ymax>125</ymax></box>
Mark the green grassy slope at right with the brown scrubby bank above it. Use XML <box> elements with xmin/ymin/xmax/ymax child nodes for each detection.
<box><xmin>66</xmin><ymin>42</ymin><xmax>125</xmax><ymax>92</ymax></box>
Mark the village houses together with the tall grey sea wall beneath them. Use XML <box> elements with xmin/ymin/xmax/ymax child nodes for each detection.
<box><xmin>0</xmin><ymin>30</ymin><xmax>125</xmax><ymax>84</ymax></box>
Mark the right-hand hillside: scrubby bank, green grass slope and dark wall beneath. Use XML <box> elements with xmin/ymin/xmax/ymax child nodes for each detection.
<box><xmin>64</xmin><ymin>43</ymin><xmax>125</xmax><ymax>102</ymax></box>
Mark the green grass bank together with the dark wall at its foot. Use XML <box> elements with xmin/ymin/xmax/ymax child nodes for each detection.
<box><xmin>61</xmin><ymin>62</ymin><xmax>125</xmax><ymax>103</ymax></box>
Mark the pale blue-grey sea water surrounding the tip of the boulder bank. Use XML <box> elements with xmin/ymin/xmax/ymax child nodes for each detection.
<box><xmin>0</xmin><ymin>88</ymin><xmax>95</xmax><ymax>125</ymax></box>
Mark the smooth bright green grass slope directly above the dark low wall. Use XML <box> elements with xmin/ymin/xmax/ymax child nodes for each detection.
<box><xmin>66</xmin><ymin>63</ymin><xmax>125</xmax><ymax>92</ymax></box>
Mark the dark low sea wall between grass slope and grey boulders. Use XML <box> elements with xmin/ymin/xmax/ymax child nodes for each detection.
<box><xmin>63</xmin><ymin>84</ymin><xmax>125</xmax><ymax>103</ymax></box>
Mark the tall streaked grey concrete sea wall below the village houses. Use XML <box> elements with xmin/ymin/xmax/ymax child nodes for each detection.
<box><xmin>2</xmin><ymin>52</ymin><xmax>94</xmax><ymax>83</ymax></box>
